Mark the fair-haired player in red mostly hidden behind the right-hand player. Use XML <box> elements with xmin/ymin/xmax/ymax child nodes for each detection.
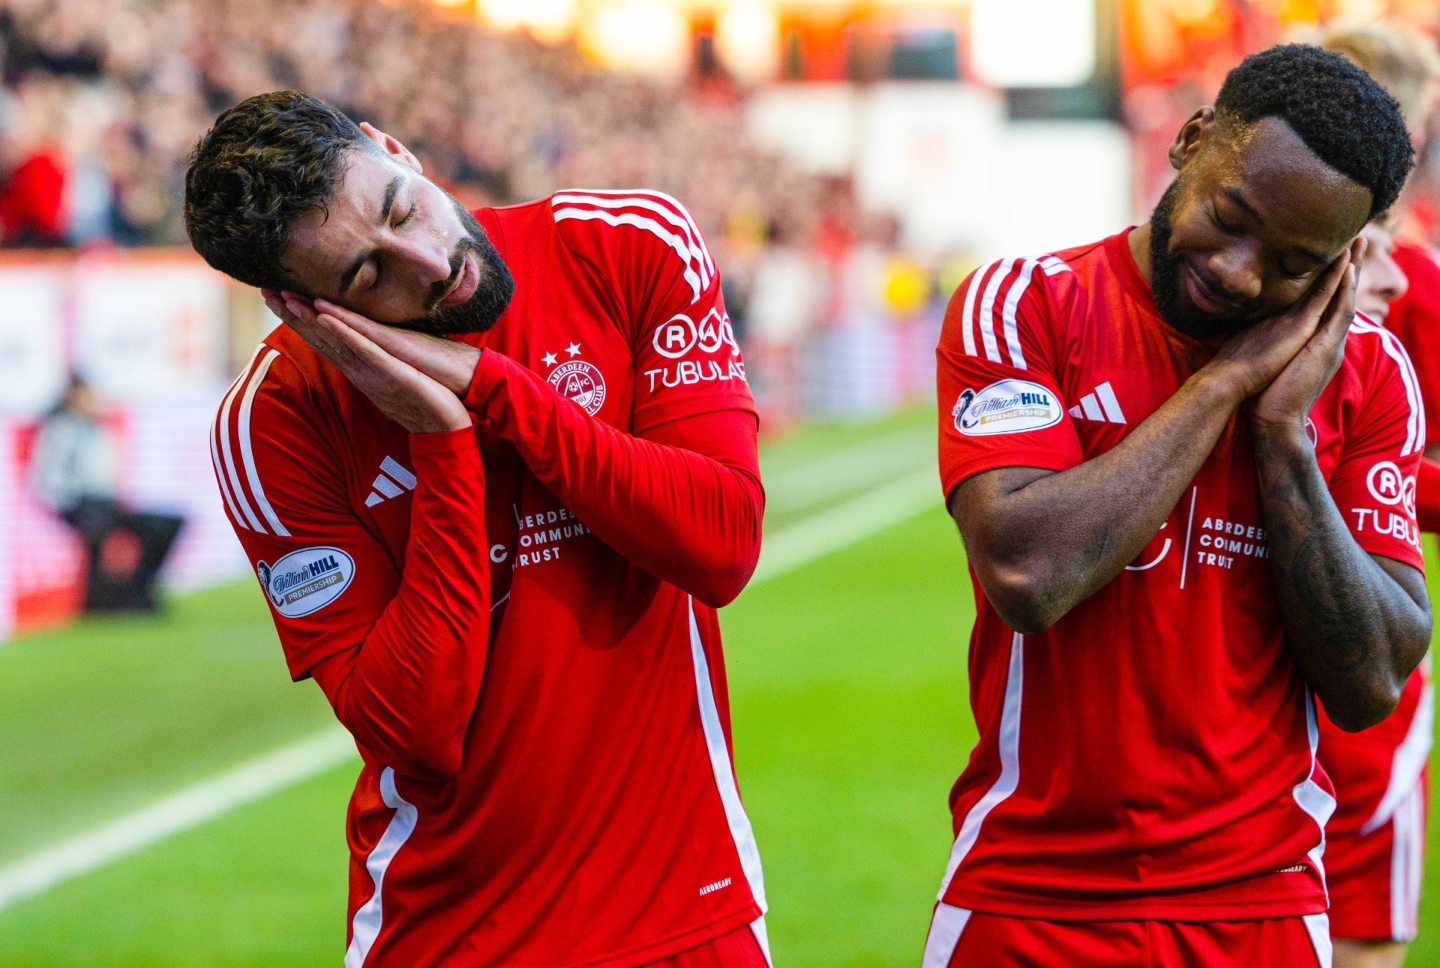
<box><xmin>1320</xmin><ymin>23</ymin><xmax>1440</xmax><ymax>968</ymax></box>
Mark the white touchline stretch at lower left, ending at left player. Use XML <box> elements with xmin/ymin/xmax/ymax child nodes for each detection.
<box><xmin>0</xmin><ymin>726</ymin><xmax>356</xmax><ymax>910</ymax></box>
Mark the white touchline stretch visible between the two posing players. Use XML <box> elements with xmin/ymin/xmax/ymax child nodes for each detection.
<box><xmin>746</xmin><ymin>468</ymin><xmax>940</xmax><ymax>588</ymax></box>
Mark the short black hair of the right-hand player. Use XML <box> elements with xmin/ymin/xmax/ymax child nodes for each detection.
<box><xmin>1215</xmin><ymin>43</ymin><xmax>1416</xmax><ymax>219</ymax></box>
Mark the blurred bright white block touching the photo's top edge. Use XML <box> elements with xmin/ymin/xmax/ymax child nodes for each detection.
<box><xmin>971</xmin><ymin>0</ymin><xmax>1096</xmax><ymax>88</ymax></box>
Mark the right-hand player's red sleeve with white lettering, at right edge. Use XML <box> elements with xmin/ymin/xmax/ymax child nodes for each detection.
<box><xmin>1329</xmin><ymin>328</ymin><xmax>1426</xmax><ymax>570</ymax></box>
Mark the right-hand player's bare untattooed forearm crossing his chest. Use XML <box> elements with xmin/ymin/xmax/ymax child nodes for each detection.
<box><xmin>967</xmin><ymin>367</ymin><xmax>1238</xmax><ymax>632</ymax></box>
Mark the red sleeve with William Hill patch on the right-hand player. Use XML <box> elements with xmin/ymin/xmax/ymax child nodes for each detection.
<box><xmin>936</xmin><ymin>259</ymin><xmax>1084</xmax><ymax>496</ymax></box>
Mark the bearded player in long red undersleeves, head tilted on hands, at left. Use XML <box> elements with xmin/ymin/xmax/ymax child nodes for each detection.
<box><xmin>186</xmin><ymin>92</ymin><xmax>769</xmax><ymax>968</ymax></box>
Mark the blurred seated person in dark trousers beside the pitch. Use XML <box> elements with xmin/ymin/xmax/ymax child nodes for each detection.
<box><xmin>30</xmin><ymin>376</ymin><xmax>184</xmax><ymax>611</ymax></box>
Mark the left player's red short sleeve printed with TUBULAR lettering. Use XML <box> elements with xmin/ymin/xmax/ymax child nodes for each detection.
<box><xmin>550</xmin><ymin>190</ymin><xmax>755</xmax><ymax>434</ymax></box>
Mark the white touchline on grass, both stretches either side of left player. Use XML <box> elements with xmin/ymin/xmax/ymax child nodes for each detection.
<box><xmin>0</xmin><ymin>458</ymin><xmax>939</xmax><ymax>910</ymax></box>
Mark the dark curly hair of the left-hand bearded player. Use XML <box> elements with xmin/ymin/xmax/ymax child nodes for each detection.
<box><xmin>184</xmin><ymin>91</ymin><xmax>374</xmax><ymax>290</ymax></box>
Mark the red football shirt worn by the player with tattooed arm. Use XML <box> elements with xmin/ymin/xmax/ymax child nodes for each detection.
<box><xmin>937</xmin><ymin>233</ymin><xmax>1424</xmax><ymax>920</ymax></box>
